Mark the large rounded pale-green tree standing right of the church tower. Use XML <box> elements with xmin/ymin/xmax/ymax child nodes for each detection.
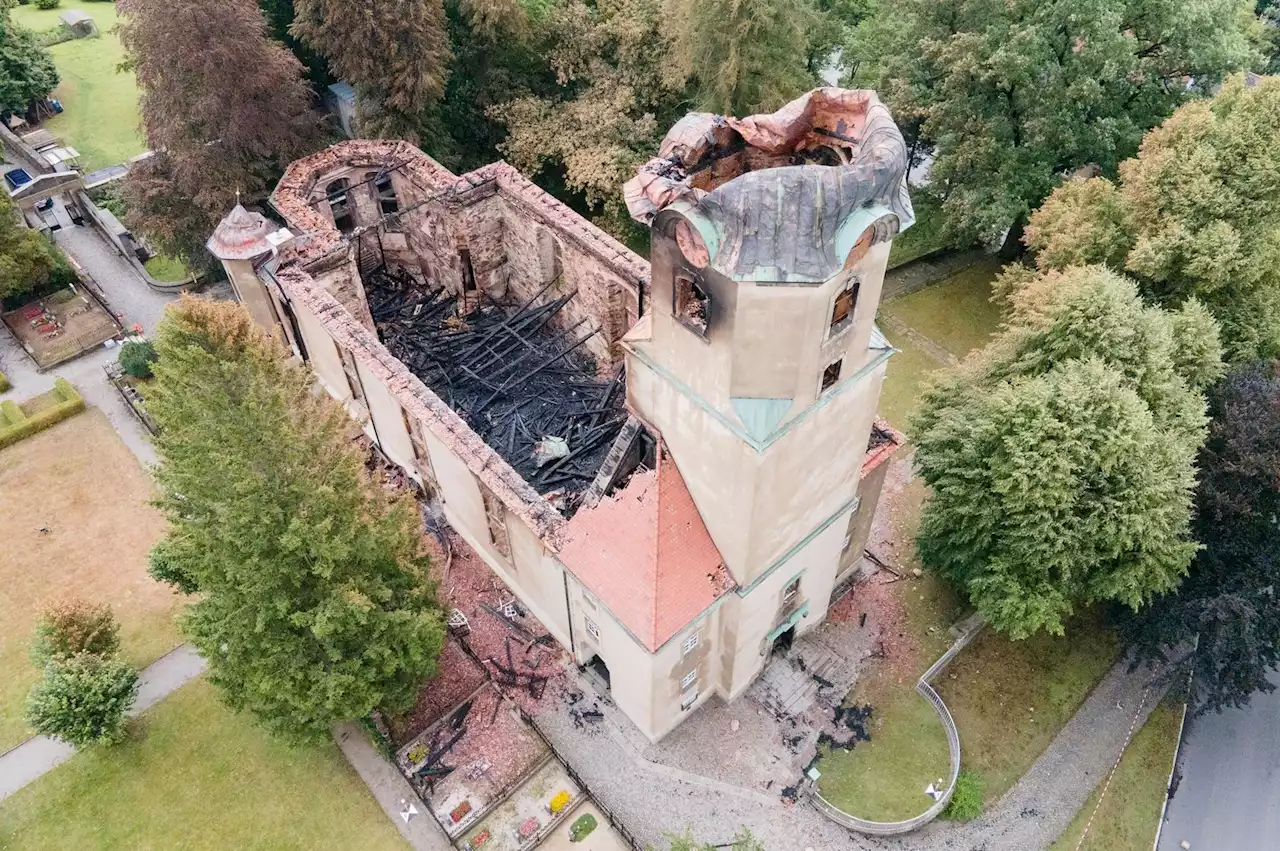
<box><xmin>911</xmin><ymin>266</ymin><xmax>1221</xmax><ymax>639</ymax></box>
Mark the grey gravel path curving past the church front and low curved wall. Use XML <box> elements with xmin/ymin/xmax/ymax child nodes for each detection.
<box><xmin>536</xmin><ymin>662</ymin><xmax>1160</xmax><ymax>851</ymax></box>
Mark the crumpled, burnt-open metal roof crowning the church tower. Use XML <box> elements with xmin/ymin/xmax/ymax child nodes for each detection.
<box><xmin>625</xmin><ymin>88</ymin><xmax>915</xmax><ymax>283</ymax></box>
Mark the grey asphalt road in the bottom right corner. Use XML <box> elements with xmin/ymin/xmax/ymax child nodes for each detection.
<box><xmin>1158</xmin><ymin>672</ymin><xmax>1280</xmax><ymax>851</ymax></box>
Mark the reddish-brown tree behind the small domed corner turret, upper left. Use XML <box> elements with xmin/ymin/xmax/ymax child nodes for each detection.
<box><xmin>119</xmin><ymin>0</ymin><xmax>320</xmax><ymax>264</ymax></box>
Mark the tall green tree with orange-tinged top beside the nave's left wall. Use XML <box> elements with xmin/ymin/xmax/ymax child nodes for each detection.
<box><xmin>147</xmin><ymin>298</ymin><xmax>444</xmax><ymax>740</ymax></box>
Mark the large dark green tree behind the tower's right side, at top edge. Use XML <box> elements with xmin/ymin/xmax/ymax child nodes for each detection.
<box><xmin>856</xmin><ymin>0</ymin><xmax>1258</xmax><ymax>243</ymax></box>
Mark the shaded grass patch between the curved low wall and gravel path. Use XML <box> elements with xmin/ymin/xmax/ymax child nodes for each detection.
<box><xmin>933</xmin><ymin>617</ymin><xmax>1120</xmax><ymax>805</ymax></box>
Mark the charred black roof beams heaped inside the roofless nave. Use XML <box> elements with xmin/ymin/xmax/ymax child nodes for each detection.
<box><xmin>365</xmin><ymin>267</ymin><xmax>627</xmax><ymax>512</ymax></box>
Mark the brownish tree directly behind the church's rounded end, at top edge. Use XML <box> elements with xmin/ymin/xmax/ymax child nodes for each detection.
<box><xmin>291</xmin><ymin>0</ymin><xmax>451</xmax><ymax>142</ymax></box>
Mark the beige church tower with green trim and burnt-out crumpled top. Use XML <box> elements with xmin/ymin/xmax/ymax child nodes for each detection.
<box><xmin>625</xmin><ymin>88</ymin><xmax>913</xmax><ymax>681</ymax></box>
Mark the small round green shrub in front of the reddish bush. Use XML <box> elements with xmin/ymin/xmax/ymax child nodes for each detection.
<box><xmin>27</xmin><ymin>653</ymin><xmax>138</xmax><ymax>747</ymax></box>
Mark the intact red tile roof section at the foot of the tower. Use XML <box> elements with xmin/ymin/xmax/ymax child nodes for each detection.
<box><xmin>559</xmin><ymin>444</ymin><xmax>735</xmax><ymax>651</ymax></box>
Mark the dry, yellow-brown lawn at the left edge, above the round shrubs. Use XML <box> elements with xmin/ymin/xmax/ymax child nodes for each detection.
<box><xmin>0</xmin><ymin>407</ymin><xmax>182</xmax><ymax>747</ymax></box>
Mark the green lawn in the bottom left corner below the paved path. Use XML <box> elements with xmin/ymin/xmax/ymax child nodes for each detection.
<box><xmin>0</xmin><ymin>680</ymin><xmax>404</xmax><ymax>851</ymax></box>
